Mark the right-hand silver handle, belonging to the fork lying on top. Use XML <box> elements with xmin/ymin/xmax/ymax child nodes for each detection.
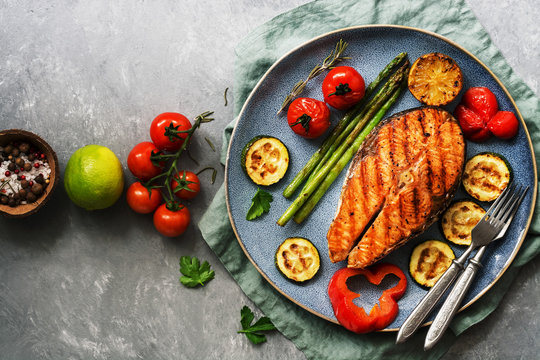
<box><xmin>424</xmin><ymin>246</ymin><xmax>486</xmax><ymax>350</ymax></box>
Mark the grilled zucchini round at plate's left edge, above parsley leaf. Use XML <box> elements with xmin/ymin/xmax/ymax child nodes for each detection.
<box><xmin>242</xmin><ymin>135</ymin><xmax>289</xmax><ymax>186</ymax></box>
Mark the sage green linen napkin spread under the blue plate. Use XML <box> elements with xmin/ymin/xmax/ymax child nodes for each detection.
<box><xmin>199</xmin><ymin>0</ymin><xmax>540</xmax><ymax>359</ymax></box>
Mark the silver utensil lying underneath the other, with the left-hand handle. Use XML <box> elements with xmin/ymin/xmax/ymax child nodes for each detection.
<box><xmin>396</xmin><ymin>186</ymin><xmax>528</xmax><ymax>344</ymax></box>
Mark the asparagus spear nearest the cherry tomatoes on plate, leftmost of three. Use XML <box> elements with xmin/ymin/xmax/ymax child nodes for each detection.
<box><xmin>283</xmin><ymin>53</ymin><xmax>407</xmax><ymax>198</ymax></box>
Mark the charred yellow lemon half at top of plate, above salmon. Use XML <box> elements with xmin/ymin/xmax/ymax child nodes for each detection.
<box><xmin>408</xmin><ymin>53</ymin><xmax>463</xmax><ymax>106</ymax></box>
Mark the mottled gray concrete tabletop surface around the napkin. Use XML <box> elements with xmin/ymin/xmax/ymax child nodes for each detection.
<box><xmin>0</xmin><ymin>0</ymin><xmax>540</xmax><ymax>359</ymax></box>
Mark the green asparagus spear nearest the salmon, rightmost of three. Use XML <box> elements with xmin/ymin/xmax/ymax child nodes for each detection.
<box><xmin>294</xmin><ymin>81</ymin><xmax>405</xmax><ymax>224</ymax></box>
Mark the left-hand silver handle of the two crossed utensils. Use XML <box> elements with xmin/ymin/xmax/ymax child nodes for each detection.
<box><xmin>396</xmin><ymin>254</ymin><xmax>466</xmax><ymax>344</ymax></box>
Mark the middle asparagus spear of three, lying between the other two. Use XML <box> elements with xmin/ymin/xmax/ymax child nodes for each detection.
<box><xmin>277</xmin><ymin>61</ymin><xmax>408</xmax><ymax>226</ymax></box>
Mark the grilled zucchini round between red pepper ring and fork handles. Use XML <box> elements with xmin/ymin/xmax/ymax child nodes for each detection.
<box><xmin>409</xmin><ymin>240</ymin><xmax>456</xmax><ymax>287</ymax></box>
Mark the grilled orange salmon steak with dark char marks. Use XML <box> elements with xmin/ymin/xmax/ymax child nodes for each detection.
<box><xmin>327</xmin><ymin>107</ymin><xmax>465</xmax><ymax>268</ymax></box>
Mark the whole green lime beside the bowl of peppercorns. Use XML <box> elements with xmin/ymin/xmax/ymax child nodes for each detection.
<box><xmin>64</xmin><ymin>145</ymin><xmax>124</xmax><ymax>210</ymax></box>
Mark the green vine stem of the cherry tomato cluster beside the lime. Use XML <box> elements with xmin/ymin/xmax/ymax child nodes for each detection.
<box><xmin>148</xmin><ymin>111</ymin><xmax>214</xmax><ymax>211</ymax></box>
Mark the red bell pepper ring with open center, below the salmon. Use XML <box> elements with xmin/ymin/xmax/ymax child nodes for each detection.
<box><xmin>328</xmin><ymin>264</ymin><xmax>407</xmax><ymax>334</ymax></box>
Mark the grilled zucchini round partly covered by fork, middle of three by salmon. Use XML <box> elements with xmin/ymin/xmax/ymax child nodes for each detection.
<box><xmin>441</xmin><ymin>200</ymin><xmax>486</xmax><ymax>245</ymax></box>
